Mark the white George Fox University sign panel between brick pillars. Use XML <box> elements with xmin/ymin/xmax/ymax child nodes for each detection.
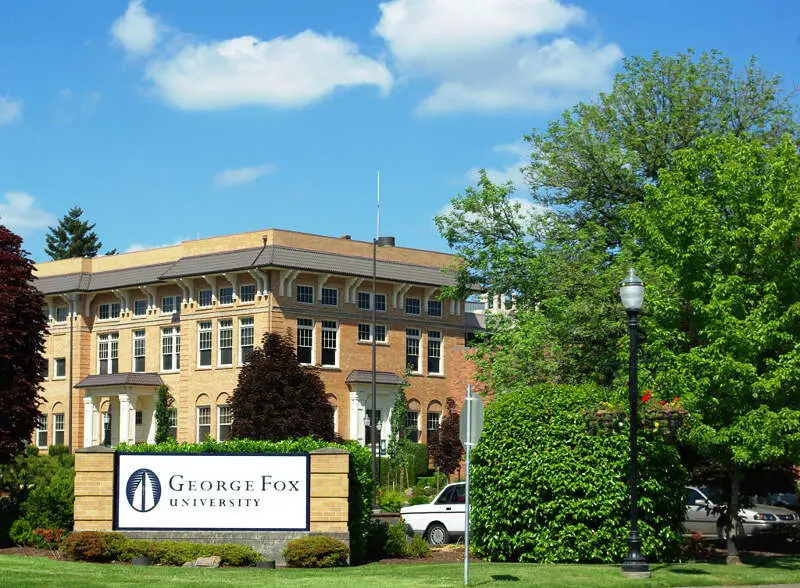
<box><xmin>114</xmin><ymin>453</ymin><xmax>310</xmax><ymax>531</ymax></box>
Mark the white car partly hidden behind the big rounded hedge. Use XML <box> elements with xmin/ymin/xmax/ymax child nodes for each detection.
<box><xmin>400</xmin><ymin>482</ymin><xmax>466</xmax><ymax>545</ymax></box>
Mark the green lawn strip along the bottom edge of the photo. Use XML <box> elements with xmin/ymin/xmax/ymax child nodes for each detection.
<box><xmin>0</xmin><ymin>556</ymin><xmax>800</xmax><ymax>588</ymax></box>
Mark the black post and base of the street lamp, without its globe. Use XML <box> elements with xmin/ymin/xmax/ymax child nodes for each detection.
<box><xmin>622</xmin><ymin>311</ymin><xmax>650</xmax><ymax>577</ymax></box>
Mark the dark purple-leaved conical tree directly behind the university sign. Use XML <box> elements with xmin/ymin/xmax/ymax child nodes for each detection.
<box><xmin>231</xmin><ymin>333</ymin><xmax>333</xmax><ymax>441</ymax></box>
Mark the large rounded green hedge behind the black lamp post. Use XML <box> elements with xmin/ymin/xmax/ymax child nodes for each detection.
<box><xmin>470</xmin><ymin>385</ymin><xmax>686</xmax><ymax>562</ymax></box>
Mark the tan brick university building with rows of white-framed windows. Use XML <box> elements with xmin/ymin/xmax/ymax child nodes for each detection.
<box><xmin>34</xmin><ymin>229</ymin><xmax>476</xmax><ymax>448</ymax></box>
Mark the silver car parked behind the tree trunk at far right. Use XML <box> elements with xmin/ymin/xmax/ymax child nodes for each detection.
<box><xmin>684</xmin><ymin>486</ymin><xmax>800</xmax><ymax>541</ymax></box>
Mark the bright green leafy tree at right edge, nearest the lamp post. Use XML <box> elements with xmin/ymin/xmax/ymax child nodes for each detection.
<box><xmin>629</xmin><ymin>136</ymin><xmax>800</xmax><ymax>555</ymax></box>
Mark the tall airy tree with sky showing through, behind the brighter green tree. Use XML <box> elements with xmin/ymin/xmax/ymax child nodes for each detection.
<box><xmin>435</xmin><ymin>51</ymin><xmax>800</xmax><ymax>390</ymax></box>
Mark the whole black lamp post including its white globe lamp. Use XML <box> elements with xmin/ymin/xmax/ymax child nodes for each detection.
<box><xmin>619</xmin><ymin>268</ymin><xmax>650</xmax><ymax>578</ymax></box>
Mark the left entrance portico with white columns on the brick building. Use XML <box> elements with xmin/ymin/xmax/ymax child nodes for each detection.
<box><xmin>75</xmin><ymin>373</ymin><xmax>163</xmax><ymax>447</ymax></box>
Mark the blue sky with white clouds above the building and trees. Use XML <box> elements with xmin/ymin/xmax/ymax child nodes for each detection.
<box><xmin>0</xmin><ymin>0</ymin><xmax>800</xmax><ymax>261</ymax></box>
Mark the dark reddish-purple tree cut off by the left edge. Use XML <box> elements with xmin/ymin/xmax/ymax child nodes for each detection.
<box><xmin>0</xmin><ymin>225</ymin><xmax>47</xmax><ymax>463</ymax></box>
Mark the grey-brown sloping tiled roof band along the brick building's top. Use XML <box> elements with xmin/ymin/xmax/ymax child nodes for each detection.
<box><xmin>33</xmin><ymin>245</ymin><xmax>456</xmax><ymax>294</ymax></box>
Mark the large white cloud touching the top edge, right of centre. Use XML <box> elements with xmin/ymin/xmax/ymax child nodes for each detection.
<box><xmin>375</xmin><ymin>0</ymin><xmax>622</xmax><ymax>114</ymax></box>
